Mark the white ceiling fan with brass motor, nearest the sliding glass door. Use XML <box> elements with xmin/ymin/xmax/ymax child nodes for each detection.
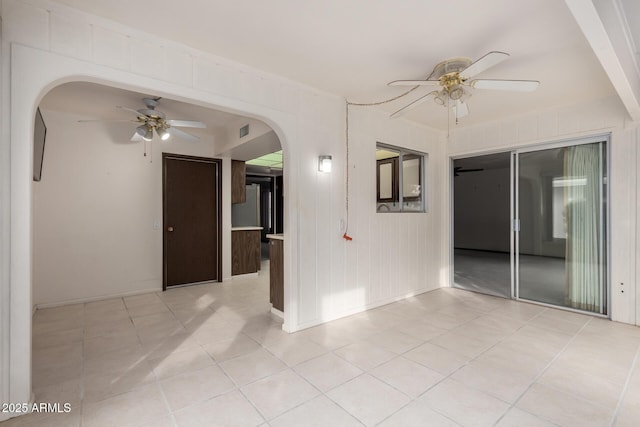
<box><xmin>388</xmin><ymin>51</ymin><xmax>540</xmax><ymax>121</ymax></box>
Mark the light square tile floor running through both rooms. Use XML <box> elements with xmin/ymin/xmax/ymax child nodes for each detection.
<box><xmin>2</xmin><ymin>269</ymin><xmax>640</xmax><ymax>427</ymax></box>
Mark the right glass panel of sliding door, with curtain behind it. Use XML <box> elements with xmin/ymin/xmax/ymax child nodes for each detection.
<box><xmin>514</xmin><ymin>141</ymin><xmax>607</xmax><ymax>314</ymax></box>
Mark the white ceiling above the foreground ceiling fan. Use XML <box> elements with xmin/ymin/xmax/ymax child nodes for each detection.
<box><xmin>47</xmin><ymin>0</ymin><xmax>628</xmax><ymax>129</ymax></box>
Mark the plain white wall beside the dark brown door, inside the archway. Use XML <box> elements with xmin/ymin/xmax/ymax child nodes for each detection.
<box><xmin>32</xmin><ymin>110</ymin><xmax>231</xmax><ymax>307</ymax></box>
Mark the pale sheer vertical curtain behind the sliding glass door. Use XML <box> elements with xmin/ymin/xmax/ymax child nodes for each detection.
<box><xmin>564</xmin><ymin>143</ymin><xmax>605</xmax><ymax>313</ymax></box>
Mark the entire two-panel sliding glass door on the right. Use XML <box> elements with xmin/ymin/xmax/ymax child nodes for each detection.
<box><xmin>452</xmin><ymin>137</ymin><xmax>609</xmax><ymax>316</ymax></box>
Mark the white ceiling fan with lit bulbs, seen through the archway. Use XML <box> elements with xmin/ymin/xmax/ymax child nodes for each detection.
<box><xmin>80</xmin><ymin>98</ymin><xmax>207</xmax><ymax>141</ymax></box>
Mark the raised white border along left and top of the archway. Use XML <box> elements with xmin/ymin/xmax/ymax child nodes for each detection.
<box><xmin>3</xmin><ymin>46</ymin><xmax>296</xmax><ymax>412</ymax></box>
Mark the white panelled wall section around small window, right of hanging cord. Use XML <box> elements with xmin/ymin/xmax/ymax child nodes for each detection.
<box><xmin>345</xmin><ymin>106</ymin><xmax>441</xmax><ymax>318</ymax></box>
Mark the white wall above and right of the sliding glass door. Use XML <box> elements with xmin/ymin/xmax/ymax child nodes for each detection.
<box><xmin>447</xmin><ymin>98</ymin><xmax>640</xmax><ymax>324</ymax></box>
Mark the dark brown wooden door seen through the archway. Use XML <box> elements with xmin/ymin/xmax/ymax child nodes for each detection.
<box><xmin>162</xmin><ymin>153</ymin><xmax>222</xmax><ymax>289</ymax></box>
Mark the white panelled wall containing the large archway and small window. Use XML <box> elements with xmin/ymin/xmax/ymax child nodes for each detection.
<box><xmin>0</xmin><ymin>0</ymin><xmax>442</xmax><ymax>417</ymax></box>
